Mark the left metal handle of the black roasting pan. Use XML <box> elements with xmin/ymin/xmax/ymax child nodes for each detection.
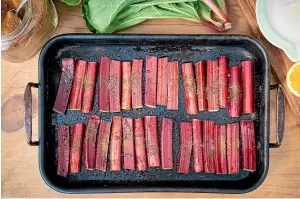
<box><xmin>24</xmin><ymin>82</ymin><xmax>39</xmax><ymax>146</ymax></box>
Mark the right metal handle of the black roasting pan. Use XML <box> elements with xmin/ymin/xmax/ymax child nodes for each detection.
<box><xmin>269</xmin><ymin>84</ymin><xmax>285</xmax><ymax>148</ymax></box>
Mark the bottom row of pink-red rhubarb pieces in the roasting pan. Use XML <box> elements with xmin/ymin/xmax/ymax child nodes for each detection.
<box><xmin>57</xmin><ymin>115</ymin><xmax>256</xmax><ymax>177</ymax></box>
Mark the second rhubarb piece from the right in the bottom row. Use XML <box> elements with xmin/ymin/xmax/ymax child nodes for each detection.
<box><xmin>227</xmin><ymin>123</ymin><xmax>240</xmax><ymax>174</ymax></box>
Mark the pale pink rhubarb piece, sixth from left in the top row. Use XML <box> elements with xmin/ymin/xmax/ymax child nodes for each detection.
<box><xmin>121</xmin><ymin>62</ymin><xmax>131</xmax><ymax>110</ymax></box>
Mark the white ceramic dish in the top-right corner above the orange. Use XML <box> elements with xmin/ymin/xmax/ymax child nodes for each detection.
<box><xmin>256</xmin><ymin>0</ymin><xmax>300</xmax><ymax>62</ymax></box>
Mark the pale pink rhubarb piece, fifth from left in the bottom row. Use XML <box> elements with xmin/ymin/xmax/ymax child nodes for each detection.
<box><xmin>109</xmin><ymin>116</ymin><xmax>122</xmax><ymax>171</ymax></box>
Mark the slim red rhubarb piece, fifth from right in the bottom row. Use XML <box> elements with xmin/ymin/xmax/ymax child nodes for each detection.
<box><xmin>192</xmin><ymin>119</ymin><xmax>203</xmax><ymax>173</ymax></box>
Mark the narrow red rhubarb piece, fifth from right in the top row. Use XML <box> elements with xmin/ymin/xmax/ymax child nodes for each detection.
<box><xmin>195</xmin><ymin>61</ymin><xmax>207</xmax><ymax>111</ymax></box>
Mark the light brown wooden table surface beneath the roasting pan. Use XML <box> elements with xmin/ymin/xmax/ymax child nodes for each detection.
<box><xmin>1</xmin><ymin>0</ymin><xmax>300</xmax><ymax>198</ymax></box>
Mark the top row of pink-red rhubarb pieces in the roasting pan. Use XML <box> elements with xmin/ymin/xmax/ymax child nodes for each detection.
<box><xmin>53</xmin><ymin>56</ymin><xmax>255</xmax><ymax>117</ymax></box>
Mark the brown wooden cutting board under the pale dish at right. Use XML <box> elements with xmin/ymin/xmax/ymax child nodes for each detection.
<box><xmin>237</xmin><ymin>0</ymin><xmax>300</xmax><ymax>123</ymax></box>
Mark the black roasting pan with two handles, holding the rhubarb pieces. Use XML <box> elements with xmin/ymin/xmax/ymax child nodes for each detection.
<box><xmin>25</xmin><ymin>34</ymin><xmax>284</xmax><ymax>193</ymax></box>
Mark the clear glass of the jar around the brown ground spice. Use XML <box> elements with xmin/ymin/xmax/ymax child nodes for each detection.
<box><xmin>1</xmin><ymin>0</ymin><xmax>58</xmax><ymax>63</ymax></box>
